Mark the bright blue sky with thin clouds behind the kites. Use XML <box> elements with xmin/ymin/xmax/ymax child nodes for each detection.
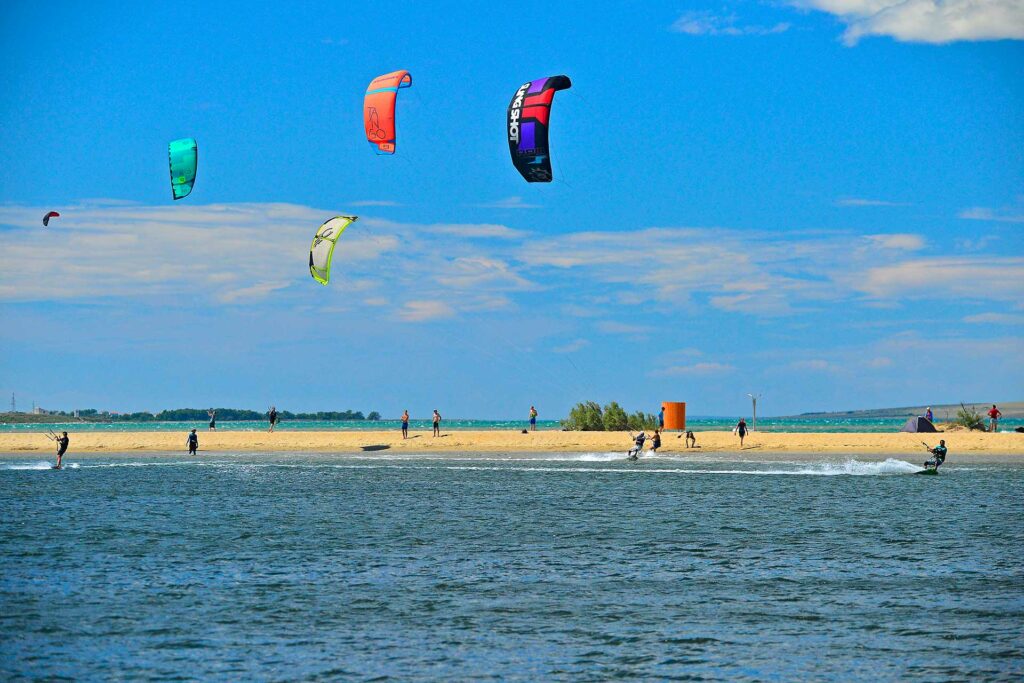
<box><xmin>0</xmin><ymin>0</ymin><xmax>1024</xmax><ymax>418</ymax></box>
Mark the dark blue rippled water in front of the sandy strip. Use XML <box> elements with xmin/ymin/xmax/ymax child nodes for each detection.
<box><xmin>0</xmin><ymin>454</ymin><xmax>1024</xmax><ymax>681</ymax></box>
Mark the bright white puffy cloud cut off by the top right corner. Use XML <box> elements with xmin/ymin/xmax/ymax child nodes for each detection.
<box><xmin>795</xmin><ymin>0</ymin><xmax>1024</xmax><ymax>45</ymax></box>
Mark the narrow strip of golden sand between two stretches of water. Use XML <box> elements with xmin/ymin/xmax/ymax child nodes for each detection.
<box><xmin>0</xmin><ymin>431</ymin><xmax>1024</xmax><ymax>458</ymax></box>
